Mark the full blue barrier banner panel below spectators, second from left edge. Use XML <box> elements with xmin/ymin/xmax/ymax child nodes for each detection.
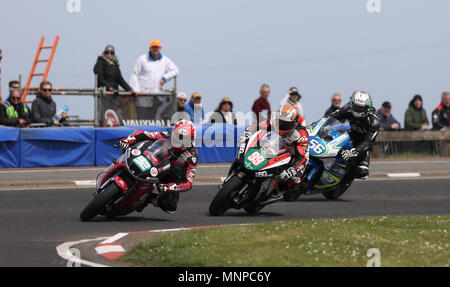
<box><xmin>20</xmin><ymin>127</ymin><xmax>95</xmax><ymax>167</ymax></box>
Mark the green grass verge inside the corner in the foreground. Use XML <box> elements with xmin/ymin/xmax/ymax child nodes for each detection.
<box><xmin>119</xmin><ymin>215</ymin><xmax>450</xmax><ymax>267</ymax></box>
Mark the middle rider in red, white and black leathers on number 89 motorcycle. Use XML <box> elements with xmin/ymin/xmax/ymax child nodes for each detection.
<box><xmin>230</xmin><ymin>104</ymin><xmax>309</xmax><ymax>198</ymax></box>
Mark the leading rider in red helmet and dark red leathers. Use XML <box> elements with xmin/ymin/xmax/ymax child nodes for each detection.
<box><xmin>120</xmin><ymin>120</ymin><xmax>198</xmax><ymax>213</ymax></box>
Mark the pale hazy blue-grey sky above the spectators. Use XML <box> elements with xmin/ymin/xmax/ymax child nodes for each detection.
<box><xmin>0</xmin><ymin>0</ymin><xmax>450</xmax><ymax>126</ymax></box>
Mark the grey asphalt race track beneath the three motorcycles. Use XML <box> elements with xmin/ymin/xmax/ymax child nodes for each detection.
<box><xmin>0</xmin><ymin>179</ymin><xmax>450</xmax><ymax>266</ymax></box>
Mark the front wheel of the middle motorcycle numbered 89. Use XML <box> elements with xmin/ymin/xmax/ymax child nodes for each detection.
<box><xmin>209</xmin><ymin>175</ymin><xmax>242</xmax><ymax>216</ymax></box>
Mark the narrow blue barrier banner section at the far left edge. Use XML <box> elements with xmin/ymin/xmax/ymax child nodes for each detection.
<box><xmin>0</xmin><ymin>127</ymin><xmax>20</xmax><ymax>168</ymax></box>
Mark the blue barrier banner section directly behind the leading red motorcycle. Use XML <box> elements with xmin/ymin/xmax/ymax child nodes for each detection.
<box><xmin>95</xmin><ymin>126</ymin><xmax>171</xmax><ymax>166</ymax></box>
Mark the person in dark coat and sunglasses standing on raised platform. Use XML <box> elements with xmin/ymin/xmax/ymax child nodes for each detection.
<box><xmin>94</xmin><ymin>45</ymin><xmax>131</xmax><ymax>92</ymax></box>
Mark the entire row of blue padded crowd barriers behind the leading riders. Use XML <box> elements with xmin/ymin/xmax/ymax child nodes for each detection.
<box><xmin>0</xmin><ymin>124</ymin><xmax>244</xmax><ymax>168</ymax></box>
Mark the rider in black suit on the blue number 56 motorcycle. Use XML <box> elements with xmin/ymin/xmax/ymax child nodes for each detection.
<box><xmin>330</xmin><ymin>91</ymin><xmax>380</xmax><ymax>179</ymax></box>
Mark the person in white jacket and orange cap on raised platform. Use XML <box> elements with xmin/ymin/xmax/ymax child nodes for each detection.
<box><xmin>130</xmin><ymin>39</ymin><xmax>179</xmax><ymax>119</ymax></box>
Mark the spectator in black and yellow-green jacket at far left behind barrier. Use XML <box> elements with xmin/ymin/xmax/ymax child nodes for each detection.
<box><xmin>0</xmin><ymin>90</ymin><xmax>31</xmax><ymax>128</ymax></box>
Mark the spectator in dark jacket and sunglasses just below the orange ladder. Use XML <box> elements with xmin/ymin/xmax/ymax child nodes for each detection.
<box><xmin>31</xmin><ymin>81</ymin><xmax>68</xmax><ymax>126</ymax></box>
